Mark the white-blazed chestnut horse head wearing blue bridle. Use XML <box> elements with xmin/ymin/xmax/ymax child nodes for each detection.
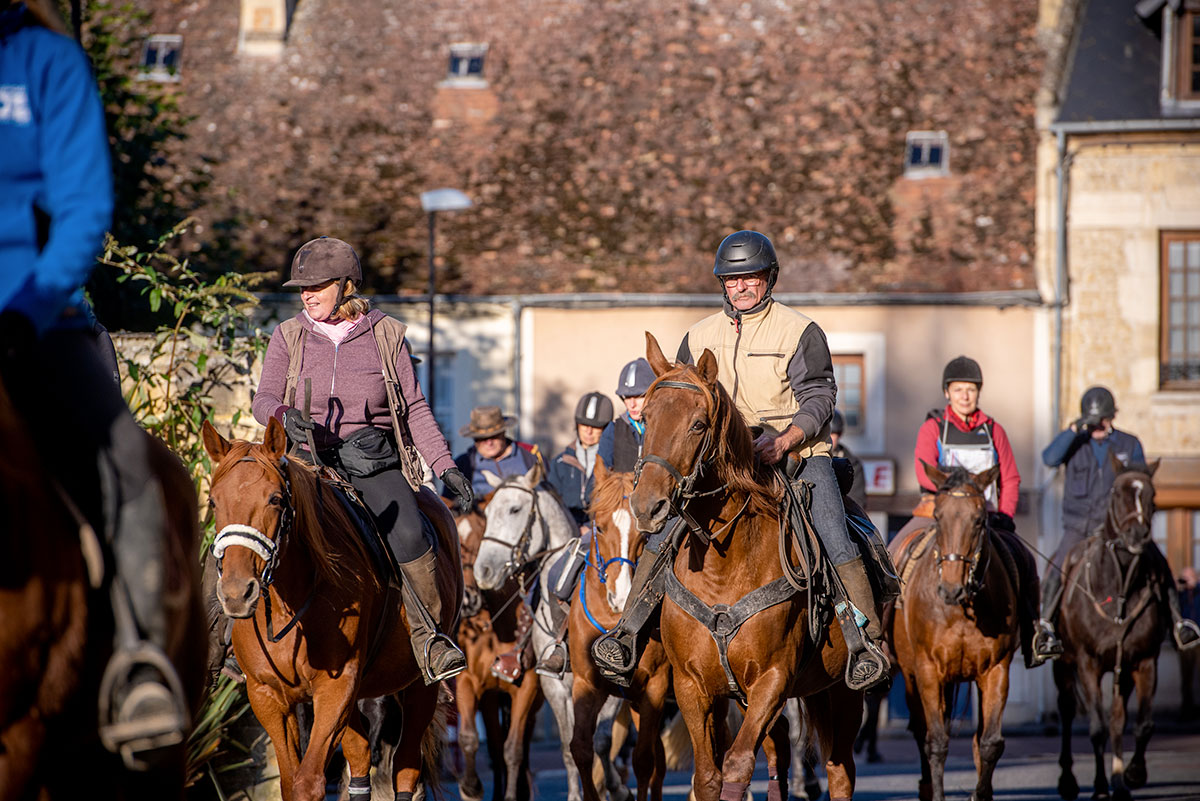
<box><xmin>588</xmin><ymin>457</ymin><xmax>646</xmax><ymax>614</ymax></box>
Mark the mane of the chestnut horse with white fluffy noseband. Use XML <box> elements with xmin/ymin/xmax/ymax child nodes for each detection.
<box><xmin>212</xmin><ymin>440</ymin><xmax>379</xmax><ymax>586</ymax></box>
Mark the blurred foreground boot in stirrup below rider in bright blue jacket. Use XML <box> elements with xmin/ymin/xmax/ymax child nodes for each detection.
<box><xmin>100</xmin><ymin>470</ymin><xmax>190</xmax><ymax>771</ymax></box>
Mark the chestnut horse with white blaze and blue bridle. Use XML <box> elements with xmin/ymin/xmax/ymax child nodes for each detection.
<box><xmin>566</xmin><ymin>459</ymin><xmax>671</xmax><ymax>801</ymax></box>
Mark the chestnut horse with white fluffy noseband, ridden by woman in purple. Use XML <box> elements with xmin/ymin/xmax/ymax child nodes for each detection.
<box><xmin>203</xmin><ymin>420</ymin><xmax>462</xmax><ymax>801</ymax></box>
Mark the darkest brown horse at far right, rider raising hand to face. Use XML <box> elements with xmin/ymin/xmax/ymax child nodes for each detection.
<box><xmin>1054</xmin><ymin>454</ymin><xmax>1171</xmax><ymax>801</ymax></box>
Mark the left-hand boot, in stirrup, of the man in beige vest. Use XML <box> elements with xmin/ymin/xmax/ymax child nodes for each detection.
<box><xmin>592</xmin><ymin>536</ymin><xmax>674</xmax><ymax>687</ymax></box>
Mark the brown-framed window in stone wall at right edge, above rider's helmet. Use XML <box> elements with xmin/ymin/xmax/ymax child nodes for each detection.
<box><xmin>1159</xmin><ymin>230</ymin><xmax>1200</xmax><ymax>390</ymax></box>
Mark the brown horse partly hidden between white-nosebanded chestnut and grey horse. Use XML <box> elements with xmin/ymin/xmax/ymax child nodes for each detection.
<box><xmin>455</xmin><ymin>501</ymin><xmax>542</xmax><ymax>801</ymax></box>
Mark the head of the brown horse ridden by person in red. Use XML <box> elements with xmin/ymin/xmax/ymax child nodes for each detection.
<box><xmin>922</xmin><ymin>459</ymin><xmax>1000</xmax><ymax>604</ymax></box>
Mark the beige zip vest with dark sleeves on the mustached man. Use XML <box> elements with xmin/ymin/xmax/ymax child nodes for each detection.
<box><xmin>678</xmin><ymin>301</ymin><xmax>838</xmax><ymax>458</ymax></box>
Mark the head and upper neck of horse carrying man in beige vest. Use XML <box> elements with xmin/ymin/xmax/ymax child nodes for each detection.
<box><xmin>630</xmin><ymin>331</ymin><xmax>776</xmax><ymax>534</ymax></box>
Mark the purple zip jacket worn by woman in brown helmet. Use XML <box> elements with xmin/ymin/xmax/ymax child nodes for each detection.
<box><xmin>251</xmin><ymin>309</ymin><xmax>454</xmax><ymax>476</ymax></box>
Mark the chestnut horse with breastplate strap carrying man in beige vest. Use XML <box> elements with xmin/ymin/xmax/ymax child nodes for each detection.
<box><xmin>630</xmin><ymin>332</ymin><xmax>863</xmax><ymax>801</ymax></box>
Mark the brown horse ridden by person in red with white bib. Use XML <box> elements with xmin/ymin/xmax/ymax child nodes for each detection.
<box><xmin>887</xmin><ymin>464</ymin><xmax>1038</xmax><ymax>801</ymax></box>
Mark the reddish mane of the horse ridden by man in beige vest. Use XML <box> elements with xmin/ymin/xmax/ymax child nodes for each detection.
<box><xmin>647</xmin><ymin>363</ymin><xmax>784</xmax><ymax>514</ymax></box>
